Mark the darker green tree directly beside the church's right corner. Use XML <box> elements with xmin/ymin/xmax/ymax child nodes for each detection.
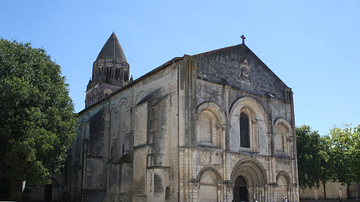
<box><xmin>296</xmin><ymin>125</ymin><xmax>332</xmax><ymax>199</ymax></box>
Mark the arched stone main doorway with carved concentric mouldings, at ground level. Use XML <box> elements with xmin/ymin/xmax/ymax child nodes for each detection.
<box><xmin>231</xmin><ymin>159</ymin><xmax>267</xmax><ymax>202</ymax></box>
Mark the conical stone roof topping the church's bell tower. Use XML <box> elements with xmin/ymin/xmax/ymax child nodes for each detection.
<box><xmin>96</xmin><ymin>32</ymin><xmax>127</xmax><ymax>62</ymax></box>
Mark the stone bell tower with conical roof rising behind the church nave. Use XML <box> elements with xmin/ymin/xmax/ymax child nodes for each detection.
<box><xmin>85</xmin><ymin>32</ymin><xmax>129</xmax><ymax>108</ymax></box>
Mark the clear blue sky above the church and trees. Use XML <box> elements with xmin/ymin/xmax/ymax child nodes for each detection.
<box><xmin>0</xmin><ymin>0</ymin><xmax>360</xmax><ymax>135</ymax></box>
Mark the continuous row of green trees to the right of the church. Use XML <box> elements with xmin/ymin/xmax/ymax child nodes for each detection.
<box><xmin>296</xmin><ymin>125</ymin><xmax>360</xmax><ymax>197</ymax></box>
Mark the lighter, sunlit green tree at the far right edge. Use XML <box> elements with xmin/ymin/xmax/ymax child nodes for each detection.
<box><xmin>330</xmin><ymin>124</ymin><xmax>360</xmax><ymax>198</ymax></box>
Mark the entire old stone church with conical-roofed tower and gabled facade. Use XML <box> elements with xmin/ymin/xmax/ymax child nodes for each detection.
<box><xmin>33</xmin><ymin>33</ymin><xmax>299</xmax><ymax>202</ymax></box>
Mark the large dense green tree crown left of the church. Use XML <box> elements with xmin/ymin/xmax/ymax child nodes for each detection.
<box><xmin>0</xmin><ymin>39</ymin><xmax>76</xmax><ymax>184</ymax></box>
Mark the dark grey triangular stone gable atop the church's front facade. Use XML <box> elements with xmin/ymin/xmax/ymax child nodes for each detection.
<box><xmin>192</xmin><ymin>44</ymin><xmax>289</xmax><ymax>102</ymax></box>
